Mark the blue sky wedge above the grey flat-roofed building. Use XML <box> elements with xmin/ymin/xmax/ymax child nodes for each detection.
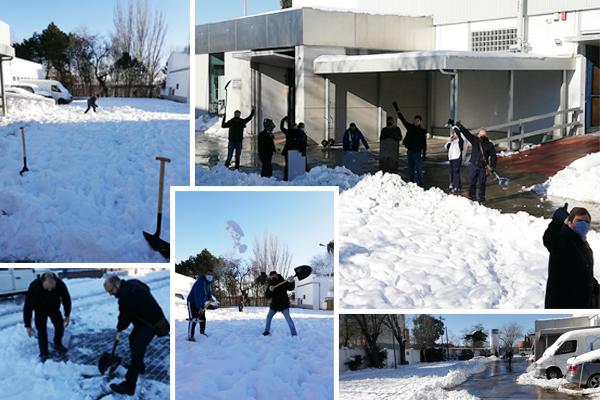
<box><xmin>196</xmin><ymin>0</ymin><xmax>281</xmax><ymax>25</ymax></box>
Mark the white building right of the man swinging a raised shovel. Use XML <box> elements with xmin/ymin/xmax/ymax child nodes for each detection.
<box><xmin>294</xmin><ymin>274</ymin><xmax>333</xmax><ymax>310</ymax></box>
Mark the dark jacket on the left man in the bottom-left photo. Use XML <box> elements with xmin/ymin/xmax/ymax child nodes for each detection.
<box><xmin>23</xmin><ymin>278</ymin><xmax>71</xmax><ymax>328</ymax></box>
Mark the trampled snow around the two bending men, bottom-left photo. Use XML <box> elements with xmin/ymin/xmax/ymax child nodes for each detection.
<box><xmin>0</xmin><ymin>270</ymin><xmax>169</xmax><ymax>400</ymax></box>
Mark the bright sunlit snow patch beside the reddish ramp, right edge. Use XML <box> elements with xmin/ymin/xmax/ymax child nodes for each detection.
<box><xmin>527</xmin><ymin>153</ymin><xmax>600</xmax><ymax>203</ymax></box>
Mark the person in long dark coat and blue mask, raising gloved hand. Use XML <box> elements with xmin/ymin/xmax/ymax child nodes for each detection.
<box><xmin>544</xmin><ymin>204</ymin><xmax>599</xmax><ymax>308</ymax></box>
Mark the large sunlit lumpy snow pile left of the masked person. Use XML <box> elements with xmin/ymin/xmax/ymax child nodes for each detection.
<box><xmin>339</xmin><ymin>173</ymin><xmax>600</xmax><ymax>308</ymax></box>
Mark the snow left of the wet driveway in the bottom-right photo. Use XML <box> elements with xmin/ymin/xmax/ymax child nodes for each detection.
<box><xmin>339</xmin><ymin>357</ymin><xmax>497</xmax><ymax>400</ymax></box>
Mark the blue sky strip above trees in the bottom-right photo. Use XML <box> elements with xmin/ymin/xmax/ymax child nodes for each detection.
<box><xmin>406</xmin><ymin>314</ymin><xmax>571</xmax><ymax>340</ymax></box>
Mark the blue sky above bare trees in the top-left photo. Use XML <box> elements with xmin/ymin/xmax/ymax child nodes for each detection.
<box><xmin>0</xmin><ymin>0</ymin><xmax>190</xmax><ymax>50</ymax></box>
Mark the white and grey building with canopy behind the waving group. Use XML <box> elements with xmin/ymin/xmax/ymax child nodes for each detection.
<box><xmin>194</xmin><ymin>0</ymin><xmax>600</xmax><ymax>146</ymax></box>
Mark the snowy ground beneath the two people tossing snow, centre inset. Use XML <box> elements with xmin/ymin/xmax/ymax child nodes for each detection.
<box><xmin>175</xmin><ymin>306</ymin><xmax>334</xmax><ymax>400</ymax></box>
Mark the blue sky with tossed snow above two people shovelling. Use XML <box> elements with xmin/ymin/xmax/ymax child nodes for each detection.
<box><xmin>175</xmin><ymin>191</ymin><xmax>333</xmax><ymax>267</ymax></box>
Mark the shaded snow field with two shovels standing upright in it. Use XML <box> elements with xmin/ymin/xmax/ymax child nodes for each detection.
<box><xmin>0</xmin><ymin>98</ymin><xmax>189</xmax><ymax>262</ymax></box>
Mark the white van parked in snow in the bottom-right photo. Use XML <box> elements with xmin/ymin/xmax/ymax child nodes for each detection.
<box><xmin>534</xmin><ymin>328</ymin><xmax>600</xmax><ymax>379</ymax></box>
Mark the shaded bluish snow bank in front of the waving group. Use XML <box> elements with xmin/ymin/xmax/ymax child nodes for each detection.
<box><xmin>196</xmin><ymin>165</ymin><xmax>362</xmax><ymax>190</ymax></box>
